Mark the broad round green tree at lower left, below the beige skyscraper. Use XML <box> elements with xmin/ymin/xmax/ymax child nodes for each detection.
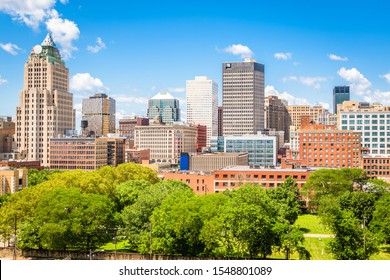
<box><xmin>20</xmin><ymin>188</ymin><xmax>115</xmax><ymax>250</ymax></box>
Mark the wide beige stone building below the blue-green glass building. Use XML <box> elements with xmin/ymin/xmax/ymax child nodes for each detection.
<box><xmin>134</xmin><ymin>123</ymin><xmax>197</xmax><ymax>164</ymax></box>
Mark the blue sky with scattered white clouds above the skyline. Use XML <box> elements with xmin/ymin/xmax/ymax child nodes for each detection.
<box><xmin>0</xmin><ymin>0</ymin><xmax>390</xmax><ymax>128</ymax></box>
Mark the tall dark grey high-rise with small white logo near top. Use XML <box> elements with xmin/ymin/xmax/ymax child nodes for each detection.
<box><xmin>222</xmin><ymin>58</ymin><xmax>264</xmax><ymax>135</ymax></box>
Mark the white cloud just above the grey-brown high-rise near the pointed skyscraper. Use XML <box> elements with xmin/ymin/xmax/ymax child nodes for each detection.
<box><xmin>70</xmin><ymin>73</ymin><xmax>109</xmax><ymax>94</ymax></box>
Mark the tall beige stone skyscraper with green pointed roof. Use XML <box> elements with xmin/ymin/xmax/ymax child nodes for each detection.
<box><xmin>16</xmin><ymin>34</ymin><xmax>75</xmax><ymax>166</ymax></box>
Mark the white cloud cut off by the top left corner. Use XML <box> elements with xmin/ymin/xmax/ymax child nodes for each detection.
<box><xmin>0</xmin><ymin>0</ymin><xmax>56</xmax><ymax>30</ymax></box>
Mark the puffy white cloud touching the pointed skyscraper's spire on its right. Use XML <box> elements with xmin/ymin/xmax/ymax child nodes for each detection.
<box><xmin>46</xmin><ymin>10</ymin><xmax>80</xmax><ymax>59</ymax></box>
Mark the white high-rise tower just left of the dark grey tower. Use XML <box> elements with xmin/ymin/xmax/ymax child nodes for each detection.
<box><xmin>186</xmin><ymin>76</ymin><xmax>218</xmax><ymax>146</ymax></box>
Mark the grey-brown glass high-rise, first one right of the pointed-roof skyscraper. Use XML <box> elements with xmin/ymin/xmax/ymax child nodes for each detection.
<box><xmin>82</xmin><ymin>93</ymin><xmax>115</xmax><ymax>137</ymax></box>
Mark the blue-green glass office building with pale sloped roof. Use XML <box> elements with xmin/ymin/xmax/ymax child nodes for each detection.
<box><xmin>148</xmin><ymin>92</ymin><xmax>180</xmax><ymax>123</ymax></box>
